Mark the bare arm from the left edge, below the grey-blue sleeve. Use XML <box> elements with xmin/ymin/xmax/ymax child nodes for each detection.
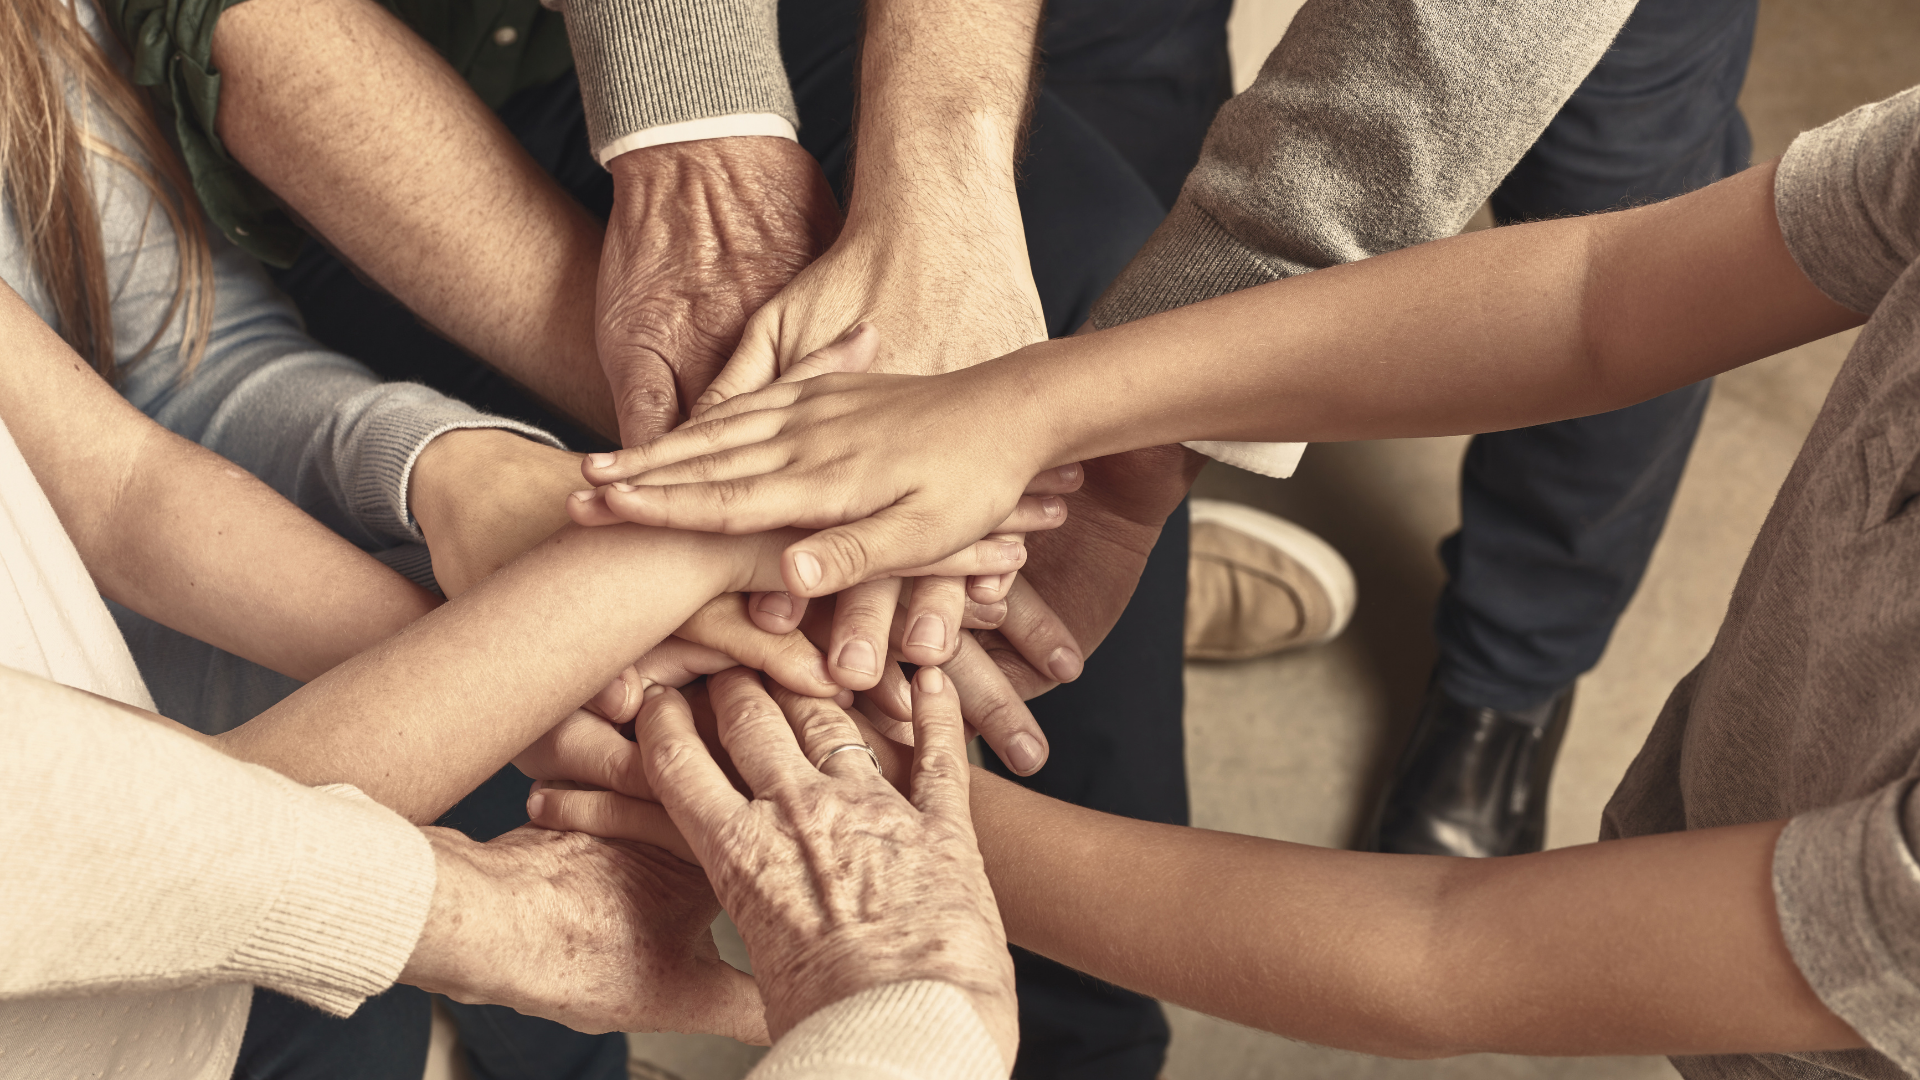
<box><xmin>0</xmin><ymin>286</ymin><xmax>439</xmax><ymax>680</ymax></box>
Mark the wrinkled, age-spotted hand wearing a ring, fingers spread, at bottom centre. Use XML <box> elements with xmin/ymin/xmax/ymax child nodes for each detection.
<box><xmin>636</xmin><ymin>669</ymin><xmax>1020</xmax><ymax>1067</ymax></box>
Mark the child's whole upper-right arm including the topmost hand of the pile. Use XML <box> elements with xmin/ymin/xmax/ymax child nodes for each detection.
<box><xmin>574</xmin><ymin>165</ymin><xmax>1862</xmax><ymax>596</ymax></box>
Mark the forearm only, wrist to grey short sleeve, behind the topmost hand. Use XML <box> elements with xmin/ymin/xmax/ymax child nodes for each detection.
<box><xmin>1000</xmin><ymin>167</ymin><xmax>1860</xmax><ymax>463</ymax></box>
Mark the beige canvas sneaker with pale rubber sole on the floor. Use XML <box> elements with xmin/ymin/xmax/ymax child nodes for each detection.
<box><xmin>1187</xmin><ymin>500</ymin><xmax>1356</xmax><ymax>659</ymax></box>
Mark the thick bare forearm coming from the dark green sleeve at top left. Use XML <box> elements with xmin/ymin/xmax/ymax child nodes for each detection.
<box><xmin>213</xmin><ymin>0</ymin><xmax>612</xmax><ymax>432</ymax></box>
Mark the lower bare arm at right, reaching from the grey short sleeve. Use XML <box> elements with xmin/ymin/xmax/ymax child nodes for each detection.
<box><xmin>973</xmin><ymin>771</ymin><xmax>1859</xmax><ymax>1057</ymax></box>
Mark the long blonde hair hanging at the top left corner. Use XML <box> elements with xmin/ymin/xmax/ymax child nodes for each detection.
<box><xmin>0</xmin><ymin>0</ymin><xmax>213</xmax><ymax>382</ymax></box>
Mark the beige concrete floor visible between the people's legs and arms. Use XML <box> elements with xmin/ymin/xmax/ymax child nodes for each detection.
<box><xmin>430</xmin><ymin>0</ymin><xmax>1920</xmax><ymax>1080</ymax></box>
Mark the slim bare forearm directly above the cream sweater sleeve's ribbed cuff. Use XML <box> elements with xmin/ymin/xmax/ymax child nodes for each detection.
<box><xmin>227</xmin><ymin>527</ymin><xmax>787</xmax><ymax>822</ymax></box>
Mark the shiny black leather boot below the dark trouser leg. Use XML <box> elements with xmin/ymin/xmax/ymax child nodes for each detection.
<box><xmin>1361</xmin><ymin>686</ymin><xmax>1572</xmax><ymax>857</ymax></box>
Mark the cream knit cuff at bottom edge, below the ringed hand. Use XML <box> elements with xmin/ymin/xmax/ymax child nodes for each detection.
<box><xmin>747</xmin><ymin>980</ymin><xmax>1008</xmax><ymax>1080</ymax></box>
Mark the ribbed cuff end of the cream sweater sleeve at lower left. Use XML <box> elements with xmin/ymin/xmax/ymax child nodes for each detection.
<box><xmin>223</xmin><ymin>784</ymin><xmax>434</xmax><ymax>1017</ymax></box>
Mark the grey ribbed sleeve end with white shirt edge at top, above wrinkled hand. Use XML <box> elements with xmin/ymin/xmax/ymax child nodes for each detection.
<box><xmin>563</xmin><ymin>0</ymin><xmax>801</xmax><ymax>161</ymax></box>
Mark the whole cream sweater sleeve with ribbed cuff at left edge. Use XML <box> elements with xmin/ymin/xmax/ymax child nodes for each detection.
<box><xmin>0</xmin><ymin>669</ymin><xmax>434</xmax><ymax>1017</ymax></box>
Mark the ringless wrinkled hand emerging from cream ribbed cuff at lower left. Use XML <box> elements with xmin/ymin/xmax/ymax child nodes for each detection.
<box><xmin>399</xmin><ymin>826</ymin><xmax>768</xmax><ymax>1043</ymax></box>
